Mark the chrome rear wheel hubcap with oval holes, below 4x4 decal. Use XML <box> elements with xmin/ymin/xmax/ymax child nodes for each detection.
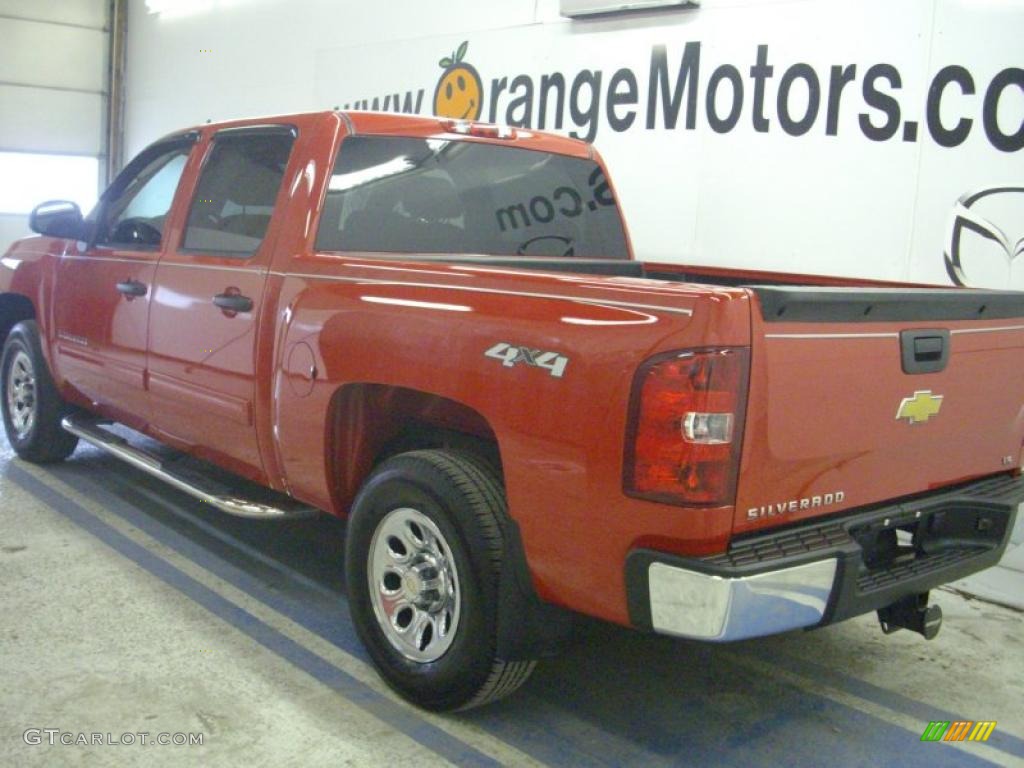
<box><xmin>367</xmin><ymin>507</ymin><xmax>461</xmax><ymax>664</ymax></box>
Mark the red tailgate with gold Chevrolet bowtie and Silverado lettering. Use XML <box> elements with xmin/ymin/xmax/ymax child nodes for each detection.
<box><xmin>733</xmin><ymin>286</ymin><xmax>1024</xmax><ymax>534</ymax></box>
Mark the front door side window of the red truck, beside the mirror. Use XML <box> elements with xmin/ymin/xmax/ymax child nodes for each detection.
<box><xmin>95</xmin><ymin>143</ymin><xmax>191</xmax><ymax>249</ymax></box>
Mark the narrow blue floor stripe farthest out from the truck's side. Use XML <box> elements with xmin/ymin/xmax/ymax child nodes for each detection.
<box><xmin>8</xmin><ymin>465</ymin><xmax>500</xmax><ymax>766</ymax></box>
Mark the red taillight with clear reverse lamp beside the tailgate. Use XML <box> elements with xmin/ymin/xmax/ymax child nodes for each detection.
<box><xmin>624</xmin><ymin>347</ymin><xmax>749</xmax><ymax>506</ymax></box>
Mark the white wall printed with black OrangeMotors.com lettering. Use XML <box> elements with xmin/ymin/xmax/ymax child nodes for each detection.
<box><xmin>127</xmin><ymin>0</ymin><xmax>1024</xmax><ymax>288</ymax></box>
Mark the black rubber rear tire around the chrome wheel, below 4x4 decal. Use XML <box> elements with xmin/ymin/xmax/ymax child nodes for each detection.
<box><xmin>345</xmin><ymin>450</ymin><xmax>537</xmax><ymax>712</ymax></box>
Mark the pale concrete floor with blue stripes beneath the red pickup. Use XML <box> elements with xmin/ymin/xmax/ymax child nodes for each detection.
<box><xmin>0</xmin><ymin>438</ymin><xmax>1024</xmax><ymax>768</ymax></box>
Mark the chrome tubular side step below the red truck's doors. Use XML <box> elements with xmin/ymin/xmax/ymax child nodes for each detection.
<box><xmin>60</xmin><ymin>416</ymin><xmax>318</xmax><ymax>520</ymax></box>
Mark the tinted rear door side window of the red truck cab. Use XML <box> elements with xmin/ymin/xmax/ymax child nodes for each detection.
<box><xmin>183</xmin><ymin>126</ymin><xmax>295</xmax><ymax>258</ymax></box>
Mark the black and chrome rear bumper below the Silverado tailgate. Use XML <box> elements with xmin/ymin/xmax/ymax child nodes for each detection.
<box><xmin>626</xmin><ymin>475</ymin><xmax>1024</xmax><ymax>642</ymax></box>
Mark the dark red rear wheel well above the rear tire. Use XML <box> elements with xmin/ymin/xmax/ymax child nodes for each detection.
<box><xmin>327</xmin><ymin>384</ymin><xmax>502</xmax><ymax>513</ymax></box>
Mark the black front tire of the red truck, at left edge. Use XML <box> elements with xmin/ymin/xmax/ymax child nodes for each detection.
<box><xmin>0</xmin><ymin>319</ymin><xmax>78</xmax><ymax>464</ymax></box>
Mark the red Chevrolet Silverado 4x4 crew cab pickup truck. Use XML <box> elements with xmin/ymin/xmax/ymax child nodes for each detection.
<box><xmin>6</xmin><ymin>112</ymin><xmax>1024</xmax><ymax>710</ymax></box>
